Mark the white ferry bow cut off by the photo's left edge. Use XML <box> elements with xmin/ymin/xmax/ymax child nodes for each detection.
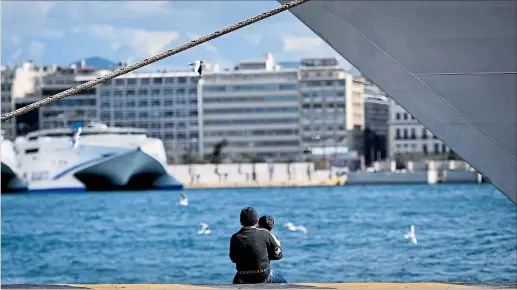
<box><xmin>0</xmin><ymin>134</ymin><xmax>26</xmax><ymax>193</ymax></box>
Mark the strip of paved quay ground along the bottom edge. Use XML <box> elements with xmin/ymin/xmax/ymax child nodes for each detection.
<box><xmin>2</xmin><ymin>283</ymin><xmax>517</xmax><ymax>290</ymax></box>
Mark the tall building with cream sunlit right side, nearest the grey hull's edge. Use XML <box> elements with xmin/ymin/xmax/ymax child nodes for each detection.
<box><xmin>300</xmin><ymin>58</ymin><xmax>364</xmax><ymax>151</ymax></box>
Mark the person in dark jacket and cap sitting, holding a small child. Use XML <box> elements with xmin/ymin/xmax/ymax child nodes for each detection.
<box><xmin>230</xmin><ymin>207</ymin><xmax>282</xmax><ymax>284</ymax></box>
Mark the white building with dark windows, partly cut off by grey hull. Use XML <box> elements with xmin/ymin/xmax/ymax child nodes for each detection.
<box><xmin>389</xmin><ymin>102</ymin><xmax>449</xmax><ymax>158</ymax></box>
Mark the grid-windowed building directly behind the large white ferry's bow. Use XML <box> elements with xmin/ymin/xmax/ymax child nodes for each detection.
<box><xmin>97</xmin><ymin>71</ymin><xmax>200</xmax><ymax>161</ymax></box>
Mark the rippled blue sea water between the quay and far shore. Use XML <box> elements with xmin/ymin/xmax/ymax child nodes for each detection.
<box><xmin>1</xmin><ymin>185</ymin><xmax>517</xmax><ymax>284</ymax></box>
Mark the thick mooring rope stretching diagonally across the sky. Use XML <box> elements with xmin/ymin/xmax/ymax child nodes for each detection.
<box><xmin>1</xmin><ymin>0</ymin><xmax>310</xmax><ymax>122</ymax></box>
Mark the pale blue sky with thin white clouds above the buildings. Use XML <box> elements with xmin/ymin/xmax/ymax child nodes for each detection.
<box><xmin>0</xmin><ymin>0</ymin><xmax>350</xmax><ymax>69</ymax></box>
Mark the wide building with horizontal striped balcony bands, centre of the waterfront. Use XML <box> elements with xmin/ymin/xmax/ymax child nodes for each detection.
<box><xmin>202</xmin><ymin>54</ymin><xmax>301</xmax><ymax>160</ymax></box>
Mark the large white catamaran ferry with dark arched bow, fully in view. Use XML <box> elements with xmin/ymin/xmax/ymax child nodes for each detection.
<box><xmin>15</xmin><ymin>123</ymin><xmax>183</xmax><ymax>192</ymax></box>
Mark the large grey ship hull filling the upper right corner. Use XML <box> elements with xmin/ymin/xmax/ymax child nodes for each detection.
<box><xmin>279</xmin><ymin>0</ymin><xmax>517</xmax><ymax>203</ymax></box>
